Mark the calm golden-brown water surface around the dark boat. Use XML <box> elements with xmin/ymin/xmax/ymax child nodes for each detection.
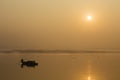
<box><xmin>0</xmin><ymin>53</ymin><xmax>120</xmax><ymax>80</ymax></box>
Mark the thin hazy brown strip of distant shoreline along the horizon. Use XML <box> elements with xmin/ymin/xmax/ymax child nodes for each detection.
<box><xmin>0</xmin><ymin>50</ymin><xmax>120</xmax><ymax>53</ymax></box>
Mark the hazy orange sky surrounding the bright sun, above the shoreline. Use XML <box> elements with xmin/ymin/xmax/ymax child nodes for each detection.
<box><xmin>0</xmin><ymin>0</ymin><xmax>120</xmax><ymax>50</ymax></box>
